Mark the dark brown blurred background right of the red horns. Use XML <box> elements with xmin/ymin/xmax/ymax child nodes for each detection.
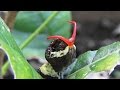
<box><xmin>72</xmin><ymin>11</ymin><xmax>120</xmax><ymax>54</ymax></box>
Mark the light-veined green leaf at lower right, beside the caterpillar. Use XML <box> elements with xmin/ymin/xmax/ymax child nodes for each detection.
<box><xmin>67</xmin><ymin>42</ymin><xmax>120</xmax><ymax>79</ymax></box>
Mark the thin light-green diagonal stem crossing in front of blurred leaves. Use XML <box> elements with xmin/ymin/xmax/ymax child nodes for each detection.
<box><xmin>2</xmin><ymin>11</ymin><xmax>58</xmax><ymax>76</ymax></box>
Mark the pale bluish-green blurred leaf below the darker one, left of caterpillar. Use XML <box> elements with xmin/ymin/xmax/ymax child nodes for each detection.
<box><xmin>12</xmin><ymin>31</ymin><xmax>50</xmax><ymax>60</ymax></box>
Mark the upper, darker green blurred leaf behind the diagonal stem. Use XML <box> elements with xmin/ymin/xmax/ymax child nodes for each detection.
<box><xmin>14</xmin><ymin>11</ymin><xmax>71</xmax><ymax>37</ymax></box>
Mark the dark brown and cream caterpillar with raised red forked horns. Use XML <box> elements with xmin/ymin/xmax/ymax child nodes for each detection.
<box><xmin>40</xmin><ymin>21</ymin><xmax>76</xmax><ymax>78</ymax></box>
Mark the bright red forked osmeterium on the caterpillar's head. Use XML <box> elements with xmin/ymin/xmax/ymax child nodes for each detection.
<box><xmin>48</xmin><ymin>21</ymin><xmax>76</xmax><ymax>47</ymax></box>
